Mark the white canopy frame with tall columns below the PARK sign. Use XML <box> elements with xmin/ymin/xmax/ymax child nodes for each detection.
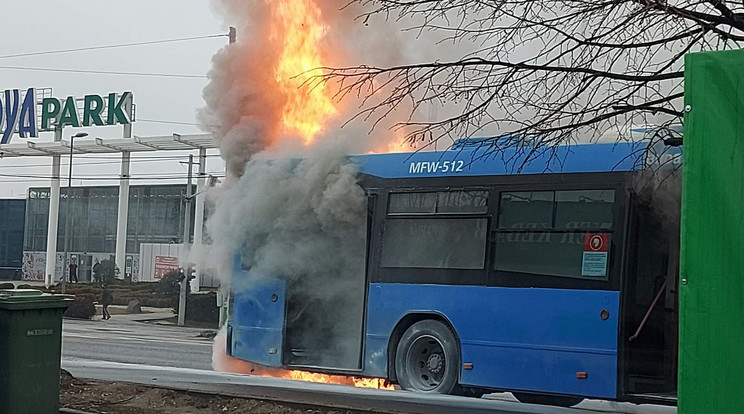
<box><xmin>0</xmin><ymin>134</ymin><xmax>217</xmax><ymax>289</ymax></box>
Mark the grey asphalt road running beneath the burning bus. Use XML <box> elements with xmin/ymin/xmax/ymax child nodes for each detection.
<box><xmin>62</xmin><ymin>315</ymin><xmax>676</xmax><ymax>414</ymax></box>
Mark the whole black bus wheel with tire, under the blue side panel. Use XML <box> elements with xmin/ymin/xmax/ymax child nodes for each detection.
<box><xmin>395</xmin><ymin>319</ymin><xmax>460</xmax><ymax>394</ymax></box>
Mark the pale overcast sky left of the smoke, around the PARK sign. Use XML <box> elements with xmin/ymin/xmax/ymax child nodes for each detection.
<box><xmin>0</xmin><ymin>0</ymin><xmax>228</xmax><ymax>198</ymax></box>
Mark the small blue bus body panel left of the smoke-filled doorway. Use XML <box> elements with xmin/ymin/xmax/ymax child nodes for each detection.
<box><xmin>228</xmin><ymin>267</ymin><xmax>286</xmax><ymax>367</ymax></box>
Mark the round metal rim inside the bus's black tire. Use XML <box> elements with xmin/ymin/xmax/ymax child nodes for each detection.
<box><xmin>406</xmin><ymin>335</ymin><xmax>447</xmax><ymax>391</ymax></box>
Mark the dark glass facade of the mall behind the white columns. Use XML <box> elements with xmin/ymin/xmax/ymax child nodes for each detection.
<box><xmin>23</xmin><ymin>185</ymin><xmax>196</xmax><ymax>254</ymax></box>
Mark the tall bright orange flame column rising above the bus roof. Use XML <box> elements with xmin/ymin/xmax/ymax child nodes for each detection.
<box><xmin>267</xmin><ymin>0</ymin><xmax>336</xmax><ymax>145</ymax></box>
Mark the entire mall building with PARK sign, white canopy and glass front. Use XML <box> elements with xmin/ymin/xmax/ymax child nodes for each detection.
<box><xmin>0</xmin><ymin>88</ymin><xmax>216</xmax><ymax>290</ymax></box>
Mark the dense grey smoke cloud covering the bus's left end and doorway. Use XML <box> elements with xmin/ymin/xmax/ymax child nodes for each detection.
<box><xmin>209</xmin><ymin>142</ymin><xmax>366</xmax><ymax>366</ymax></box>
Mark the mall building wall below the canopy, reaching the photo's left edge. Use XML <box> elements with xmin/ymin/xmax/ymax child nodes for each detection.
<box><xmin>0</xmin><ymin>184</ymin><xmax>217</xmax><ymax>287</ymax></box>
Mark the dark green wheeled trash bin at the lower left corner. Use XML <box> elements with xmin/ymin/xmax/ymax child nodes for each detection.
<box><xmin>0</xmin><ymin>289</ymin><xmax>73</xmax><ymax>414</ymax></box>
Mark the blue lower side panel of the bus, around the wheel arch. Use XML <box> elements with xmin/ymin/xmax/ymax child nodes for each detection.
<box><xmin>365</xmin><ymin>283</ymin><xmax>619</xmax><ymax>398</ymax></box>
